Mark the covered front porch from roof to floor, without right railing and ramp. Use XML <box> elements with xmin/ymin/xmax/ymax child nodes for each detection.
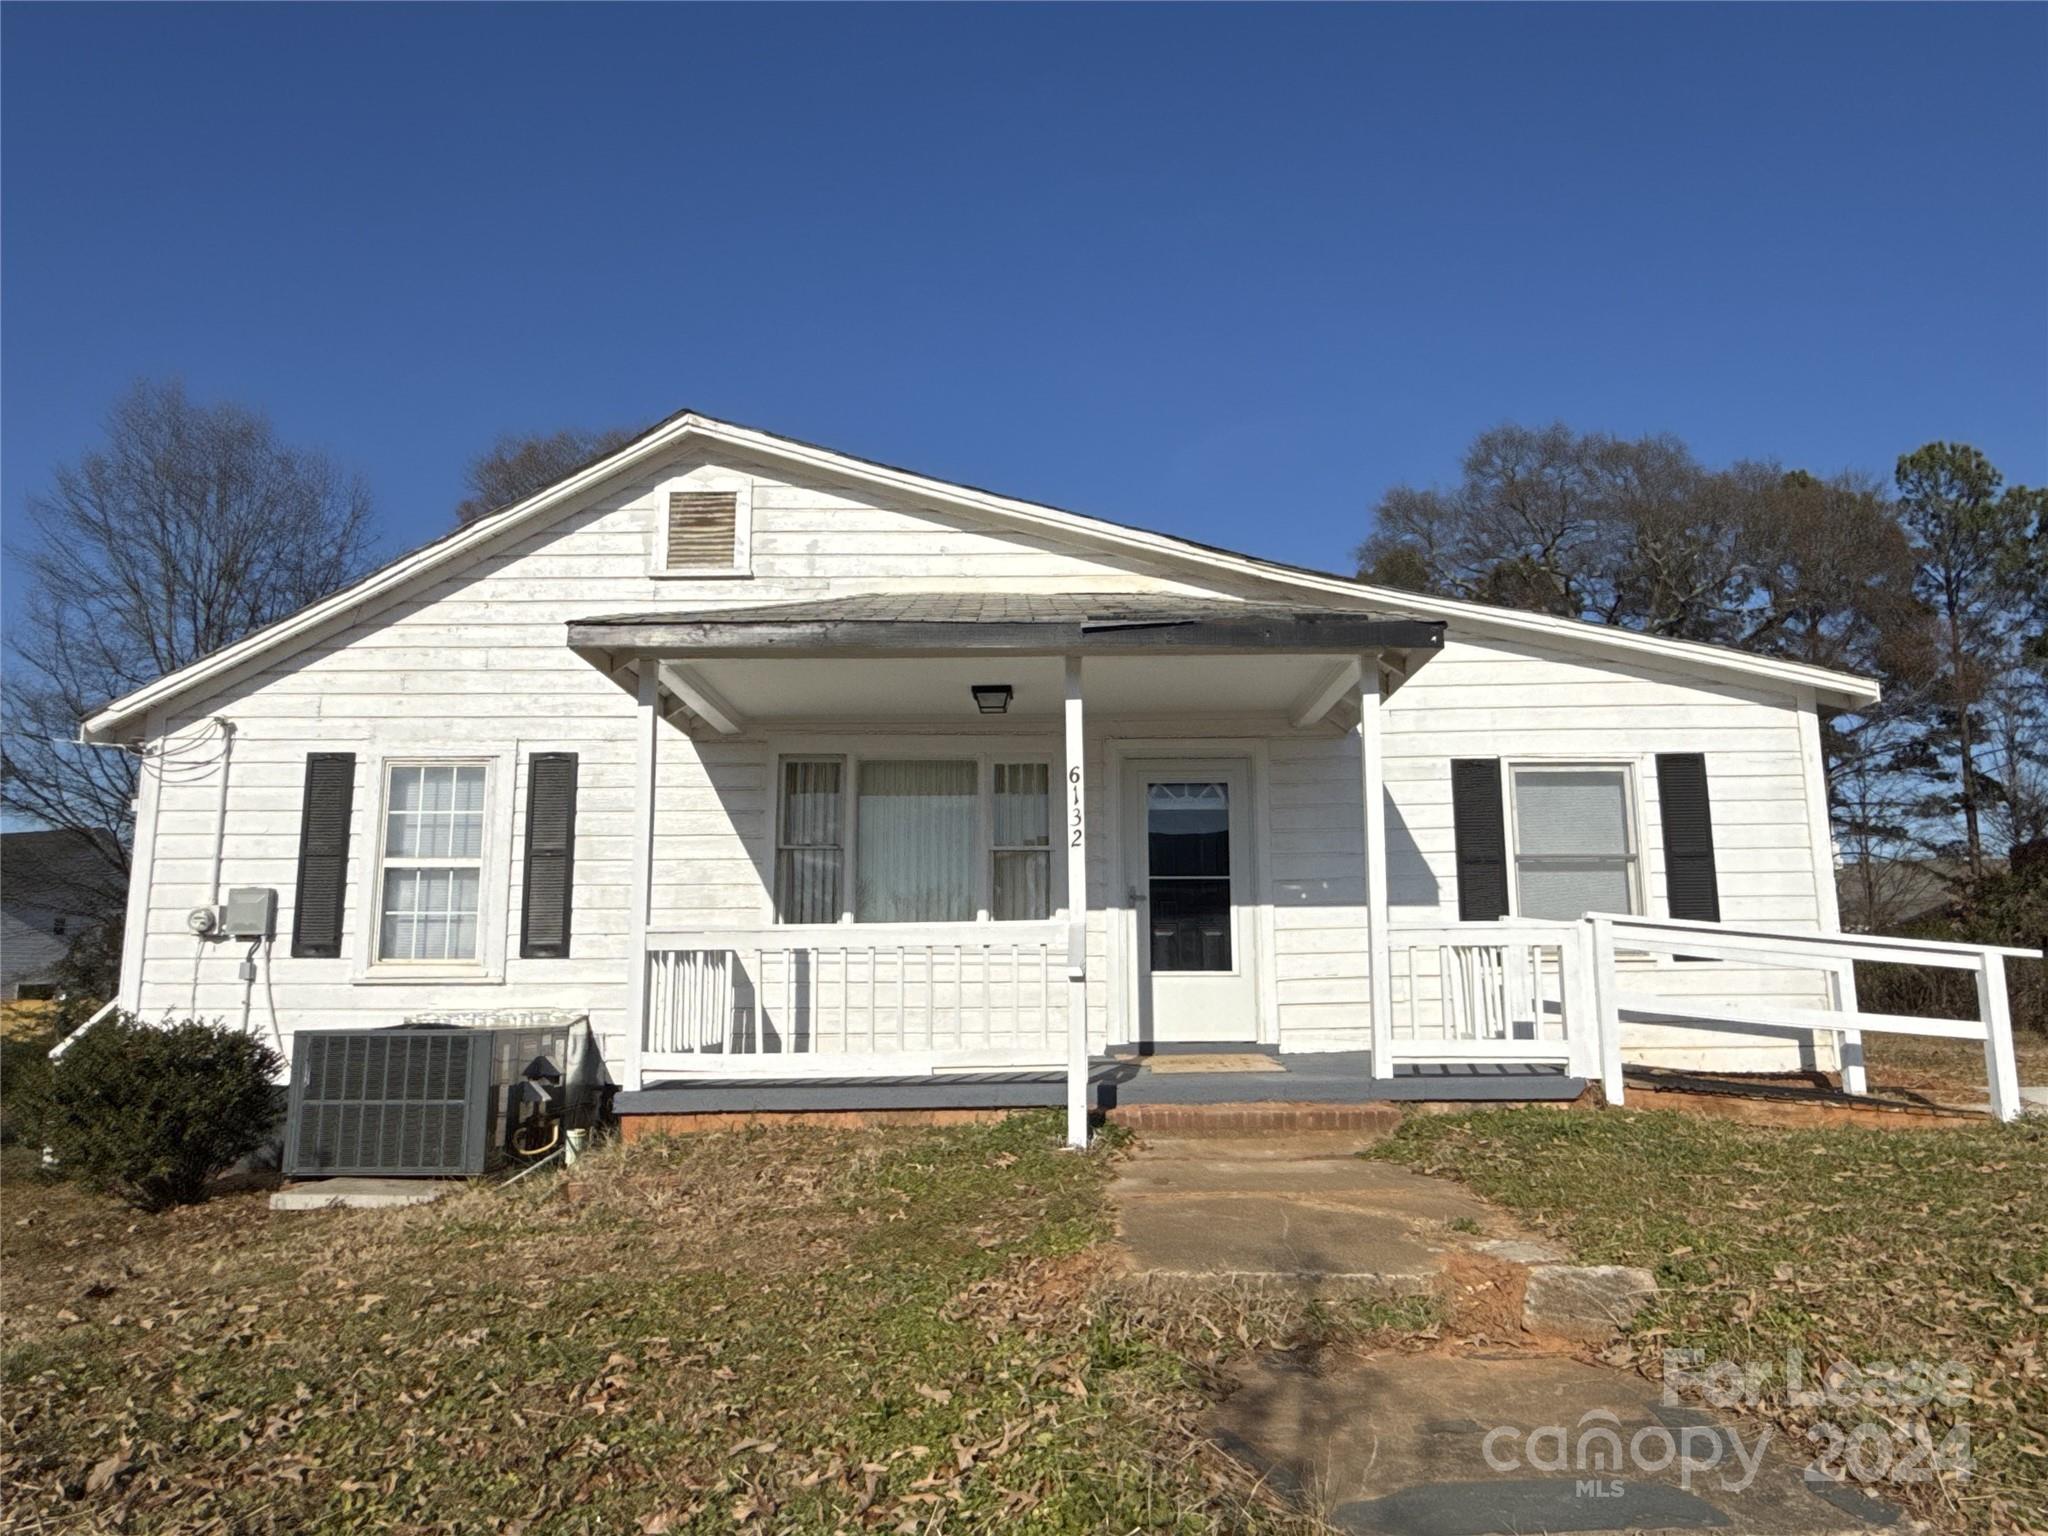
<box><xmin>569</xmin><ymin>594</ymin><xmax>1474</xmax><ymax>1112</ymax></box>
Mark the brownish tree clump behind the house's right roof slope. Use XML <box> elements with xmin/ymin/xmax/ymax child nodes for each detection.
<box><xmin>1358</xmin><ymin>426</ymin><xmax>1952</xmax><ymax>909</ymax></box>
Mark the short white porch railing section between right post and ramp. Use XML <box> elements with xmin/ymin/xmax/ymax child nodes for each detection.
<box><xmin>1389</xmin><ymin>922</ymin><xmax>1599</xmax><ymax>1077</ymax></box>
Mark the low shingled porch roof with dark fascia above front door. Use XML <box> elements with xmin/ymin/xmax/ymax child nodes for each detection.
<box><xmin>569</xmin><ymin>592</ymin><xmax>1444</xmax><ymax>655</ymax></box>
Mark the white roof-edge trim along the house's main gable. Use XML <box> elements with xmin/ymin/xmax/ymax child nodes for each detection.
<box><xmin>84</xmin><ymin>412</ymin><xmax>1878</xmax><ymax>741</ymax></box>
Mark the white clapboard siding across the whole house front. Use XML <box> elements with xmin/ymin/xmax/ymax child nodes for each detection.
<box><xmin>133</xmin><ymin>438</ymin><xmax>1829</xmax><ymax>1065</ymax></box>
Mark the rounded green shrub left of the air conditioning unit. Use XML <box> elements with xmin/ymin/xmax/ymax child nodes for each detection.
<box><xmin>35</xmin><ymin>1014</ymin><xmax>285</xmax><ymax>1210</ymax></box>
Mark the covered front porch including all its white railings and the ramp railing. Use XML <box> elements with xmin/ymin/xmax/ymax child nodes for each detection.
<box><xmin>569</xmin><ymin>594</ymin><xmax>2039</xmax><ymax>1143</ymax></box>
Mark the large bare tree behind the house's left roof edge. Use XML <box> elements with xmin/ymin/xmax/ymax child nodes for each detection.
<box><xmin>0</xmin><ymin>381</ymin><xmax>371</xmax><ymax>895</ymax></box>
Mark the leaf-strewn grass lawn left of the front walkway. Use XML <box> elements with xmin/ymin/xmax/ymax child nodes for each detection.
<box><xmin>0</xmin><ymin>1114</ymin><xmax>1359</xmax><ymax>1536</ymax></box>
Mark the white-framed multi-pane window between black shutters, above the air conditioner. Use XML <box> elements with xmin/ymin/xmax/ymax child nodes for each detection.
<box><xmin>377</xmin><ymin>762</ymin><xmax>489</xmax><ymax>965</ymax></box>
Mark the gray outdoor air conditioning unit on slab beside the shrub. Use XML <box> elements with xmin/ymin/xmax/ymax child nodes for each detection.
<box><xmin>285</xmin><ymin>1024</ymin><xmax>569</xmax><ymax>1178</ymax></box>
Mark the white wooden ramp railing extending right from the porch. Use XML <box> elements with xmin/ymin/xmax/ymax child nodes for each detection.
<box><xmin>1585</xmin><ymin>913</ymin><xmax>2040</xmax><ymax>1120</ymax></box>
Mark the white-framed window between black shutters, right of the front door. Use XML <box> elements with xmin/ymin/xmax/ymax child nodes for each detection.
<box><xmin>1511</xmin><ymin>764</ymin><xmax>1640</xmax><ymax>918</ymax></box>
